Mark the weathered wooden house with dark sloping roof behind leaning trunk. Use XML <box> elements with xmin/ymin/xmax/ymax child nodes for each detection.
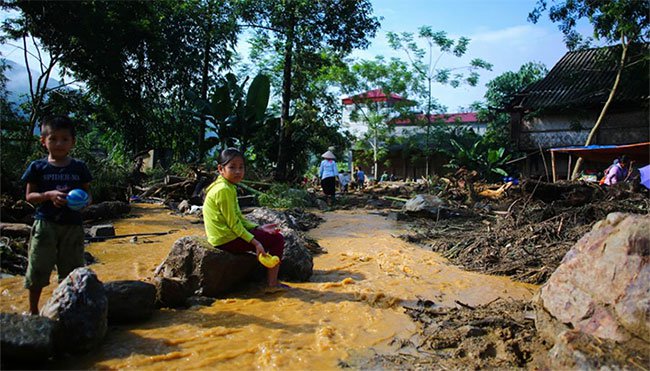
<box><xmin>508</xmin><ymin>44</ymin><xmax>650</xmax><ymax>178</ymax></box>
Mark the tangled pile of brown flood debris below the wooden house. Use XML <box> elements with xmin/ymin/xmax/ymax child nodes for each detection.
<box><xmin>392</xmin><ymin>181</ymin><xmax>650</xmax><ymax>284</ymax></box>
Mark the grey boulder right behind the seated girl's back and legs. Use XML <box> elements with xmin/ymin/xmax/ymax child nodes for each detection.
<box><xmin>246</xmin><ymin>208</ymin><xmax>314</xmax><ymax>282</ymax></box>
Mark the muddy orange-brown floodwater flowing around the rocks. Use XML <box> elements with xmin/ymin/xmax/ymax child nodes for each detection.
<box><xmin>0</xmin><ymin>205</ymin><xmax>537</xmax><ymax>370</ymax></box>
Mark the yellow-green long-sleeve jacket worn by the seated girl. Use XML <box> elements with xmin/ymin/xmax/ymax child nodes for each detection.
<box><xmin>203</xmin><ymin>176</ymin><xmax>257</xmax><ymax>246</ymax></box>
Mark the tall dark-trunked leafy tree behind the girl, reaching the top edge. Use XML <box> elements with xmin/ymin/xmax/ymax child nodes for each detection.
<box><xmin>238</xmin><ymin>0</ymin><xmax>379</xmax><ymax>180</ymax></box>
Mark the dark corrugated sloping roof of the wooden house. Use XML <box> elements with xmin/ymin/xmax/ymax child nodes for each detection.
<box><xmin>511</xmin><ymin>44</ymin><xmax>650</xmax><ymax>109</ymax></box>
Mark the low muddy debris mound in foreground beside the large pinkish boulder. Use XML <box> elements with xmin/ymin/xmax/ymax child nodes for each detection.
<box><xmin>340</xmin><ymin>299</ymin><xmax>547</xmax><ymax>370</ymax></box>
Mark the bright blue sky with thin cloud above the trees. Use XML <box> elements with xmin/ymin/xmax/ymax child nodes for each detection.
<box><xmin>353</xmin><ymin>0</ymin><xmax>591</xmax><ymax>113</ymax></box>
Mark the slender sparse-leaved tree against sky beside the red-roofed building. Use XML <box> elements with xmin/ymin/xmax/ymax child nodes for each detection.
<box><xmin>387</xmin><ymin>26</ymin><xmax>492</xmax><ymax>176</ymax></box>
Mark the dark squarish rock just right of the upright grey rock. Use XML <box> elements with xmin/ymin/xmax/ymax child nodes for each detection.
<box><xmin>104</xmin><ymin>280</ymin><xmax>156</xmax><ymax>324</ymax></box>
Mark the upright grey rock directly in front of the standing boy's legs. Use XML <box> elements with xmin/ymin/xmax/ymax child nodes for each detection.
<box><xmin>41</xmin><ymin>268</ymin><xmax>108</xmax><ymax>352</ymax></box>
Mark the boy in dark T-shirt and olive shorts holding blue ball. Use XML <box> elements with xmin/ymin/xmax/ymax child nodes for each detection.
<box><xmin>22</xmin><ymin>116</ymin><xmax>92</xmax><ymax>315</ymax></box>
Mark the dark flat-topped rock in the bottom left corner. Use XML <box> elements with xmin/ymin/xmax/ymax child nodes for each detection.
<box><xmin>0</xmin><ymin>313</ymin><xmax>56</xmax><ymax>369</ymax></box>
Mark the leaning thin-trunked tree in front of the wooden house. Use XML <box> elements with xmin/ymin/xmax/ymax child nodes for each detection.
<box><xmin>528</xmin><ymin>0</ymin><xmax>650</xmax><ymax>179</ymax></box>
